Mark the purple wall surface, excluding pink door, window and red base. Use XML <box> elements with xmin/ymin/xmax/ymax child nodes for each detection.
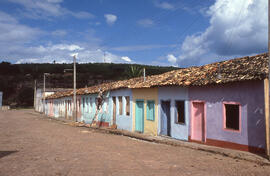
<box><xmin>189</xmin><ymin>81</ymin><xmax>265</xmax><ymax>148</ymax></box>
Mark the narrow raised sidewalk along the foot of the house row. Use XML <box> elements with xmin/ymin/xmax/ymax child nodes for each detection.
<box><xmin>33</xmin><ymin>112</ymin><xmax>270</xmax><ymax>165</ymax></box>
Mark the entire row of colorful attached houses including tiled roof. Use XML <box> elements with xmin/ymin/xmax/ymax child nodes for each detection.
<box><xmin>42</xmin><ymin>54</ymin><xmax>268</xmax><ymax>152</ymax></box>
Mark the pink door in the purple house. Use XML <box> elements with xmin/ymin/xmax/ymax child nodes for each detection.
<box><xmin>191</xmin><ymin>102</ymin><xmax>205</xmax><ymax>142</ymax></box>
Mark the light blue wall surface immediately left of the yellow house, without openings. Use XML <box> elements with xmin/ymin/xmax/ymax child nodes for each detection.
<box><xmin>110</xmin><ymin>89</ymin><xmax>132</xmax><ymax>131</ymax></box>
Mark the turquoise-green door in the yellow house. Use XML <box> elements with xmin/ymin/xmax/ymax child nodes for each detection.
<box><xmin>135</xmin><ymin>100</ymin><xmax>144</xmax><ymax>133</ymax></box>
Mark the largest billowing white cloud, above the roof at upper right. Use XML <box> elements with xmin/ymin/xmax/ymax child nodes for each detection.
<box><xmin>175</xmin><ymin>0</ymin><xmax>268</xmax><ymax>65</ymax></box>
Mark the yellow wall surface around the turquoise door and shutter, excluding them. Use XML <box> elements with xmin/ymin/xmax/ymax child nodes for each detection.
<box><xmin>132</xmin><ymin>88</ymin><xmax>158</xmax><ymax>136</ymax></box>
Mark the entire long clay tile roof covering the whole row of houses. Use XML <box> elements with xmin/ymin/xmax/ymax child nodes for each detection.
<box><xmin>47</xmin><ymin>53</ymin><xmax>268</xmax><ymax>99</ymax></box>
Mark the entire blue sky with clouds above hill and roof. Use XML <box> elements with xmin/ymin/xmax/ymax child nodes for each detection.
<box><xmin>0</xmin><ymin>0</ymin><xmax>268</xmax><ymax>67</ymax></box>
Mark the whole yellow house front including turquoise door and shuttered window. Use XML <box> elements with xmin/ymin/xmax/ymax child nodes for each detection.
<box><xmin>132</xmin><ymin>88</ymin><xmax>158</xmax><ymax>136</ymax></box>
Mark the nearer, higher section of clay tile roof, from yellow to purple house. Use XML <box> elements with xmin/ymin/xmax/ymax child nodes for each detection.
<box><xmin>129</xmin><ymin>53</ymin><xmax>268</xmax><ymax>88</ymax></box>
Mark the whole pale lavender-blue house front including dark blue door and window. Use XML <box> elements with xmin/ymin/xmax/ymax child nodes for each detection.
<box><xmin>158</xmin><ymin>87</ymin><xmax>189</xmax><ymax>140</ymax></box>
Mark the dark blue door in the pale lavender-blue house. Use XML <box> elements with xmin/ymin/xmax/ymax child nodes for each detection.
<box><xmin>160</xmin><ymin>101</ymin><xmax>171</xmax><ymax>136</ymax></box>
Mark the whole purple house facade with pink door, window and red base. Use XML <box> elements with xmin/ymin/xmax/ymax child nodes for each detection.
<box><xmin>189</xmin><ymin>81</ymin><xmax>265</xmax><ymax>152</ymax></box>
